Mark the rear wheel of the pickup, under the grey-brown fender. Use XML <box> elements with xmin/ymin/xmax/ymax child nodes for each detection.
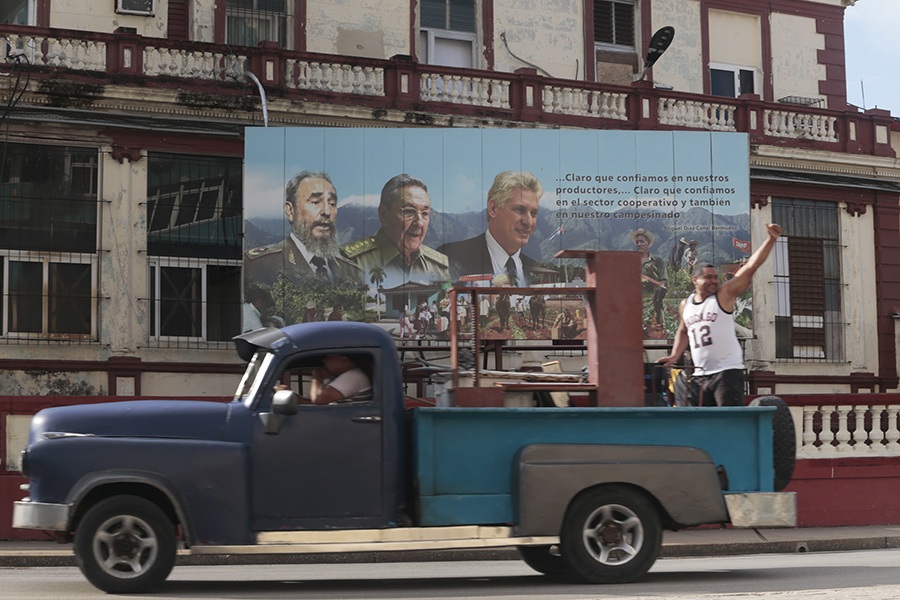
<box><xmin>560</xmin><ymin>486</ymin><xmax>662</xmax><ymax>583</ymax></box>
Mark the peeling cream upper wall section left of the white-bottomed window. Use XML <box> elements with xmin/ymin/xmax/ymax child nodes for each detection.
<box><xmin>306</xmin><ymin>0</ymin><xmax>411</xmax><ymax>58</ymax></box>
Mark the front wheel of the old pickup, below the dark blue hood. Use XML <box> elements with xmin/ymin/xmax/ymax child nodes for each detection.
<box><xmin>74</xmin><ymin>496</ymin><xmax>177</xmax><ymax>594</ymax></box>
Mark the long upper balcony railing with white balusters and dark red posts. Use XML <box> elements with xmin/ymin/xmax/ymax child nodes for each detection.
<box><xmin>0</xmin><ymin>25</ymin><xmax>895</xmax><ymax>157</ymax></box>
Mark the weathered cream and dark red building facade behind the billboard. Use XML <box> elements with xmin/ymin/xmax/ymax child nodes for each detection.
<box><xmin>0</xmin><ymin>0</ymin><xmax>900</xmax><ymax>406</ymax></box>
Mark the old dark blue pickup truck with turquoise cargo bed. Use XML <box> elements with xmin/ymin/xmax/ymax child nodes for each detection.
<box><xmin>13</xmin><ymin>322</ymin><xmax>796</xmax><ymax>593</ymax></box>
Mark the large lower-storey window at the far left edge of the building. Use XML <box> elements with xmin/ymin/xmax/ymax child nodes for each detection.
<box><xmin>0</xmin><ymin>144</ymin><xmax>98</xmax><ymax>341</ymax></box>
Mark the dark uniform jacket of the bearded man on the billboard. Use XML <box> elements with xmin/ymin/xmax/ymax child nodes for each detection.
<box><xmin>244</xmin><ymin>238</ymin><xmax>362</xmax><ymax>286</ymax></box>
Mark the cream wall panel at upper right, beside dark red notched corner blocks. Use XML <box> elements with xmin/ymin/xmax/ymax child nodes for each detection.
<box><xmin>771</xmin><ymin>13</ymin><xmax>826</xmax><ymax>106</ymax></box>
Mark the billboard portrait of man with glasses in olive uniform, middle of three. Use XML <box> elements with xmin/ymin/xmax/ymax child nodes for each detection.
<box><xmin>343</xmin><ymin>173</ymin><xmax>450</xmax><ymax>287</ymax></box>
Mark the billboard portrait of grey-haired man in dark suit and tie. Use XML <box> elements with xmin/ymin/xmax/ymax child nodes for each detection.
<box><xmin>438</xmin><ymin>171</ymin><xmax>544</xmax><ymax>287</ymax></box>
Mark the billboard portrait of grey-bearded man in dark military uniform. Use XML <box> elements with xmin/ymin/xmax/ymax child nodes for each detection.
<box><xmin>244</xmin><ymin>171</ymin><xmax>362</xmax><ymax>286</ymax></box>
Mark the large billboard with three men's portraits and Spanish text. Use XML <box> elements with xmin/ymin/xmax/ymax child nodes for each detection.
<box><xmin>244</xmin><ymin>127</ymin><xmax>752</xmax><ymax>340</ymax></box>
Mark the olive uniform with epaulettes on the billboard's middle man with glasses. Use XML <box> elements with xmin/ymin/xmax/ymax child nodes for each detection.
<box><xmin>341</xmin><ymin>229</ymin><xmax>450</xmax><ymax>287</ymax></box>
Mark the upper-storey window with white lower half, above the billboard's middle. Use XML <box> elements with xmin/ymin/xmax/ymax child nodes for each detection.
<box><xmin>419</xmin><ymin>0</ymin><xmax>476</xmax><ymax>68</ymax></box>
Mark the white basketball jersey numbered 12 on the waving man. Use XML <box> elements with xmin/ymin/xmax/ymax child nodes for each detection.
<box><xmin>681</xmin><ymin>294</ymin><xmax>744</xmax><ymax>375</ymax></box>
